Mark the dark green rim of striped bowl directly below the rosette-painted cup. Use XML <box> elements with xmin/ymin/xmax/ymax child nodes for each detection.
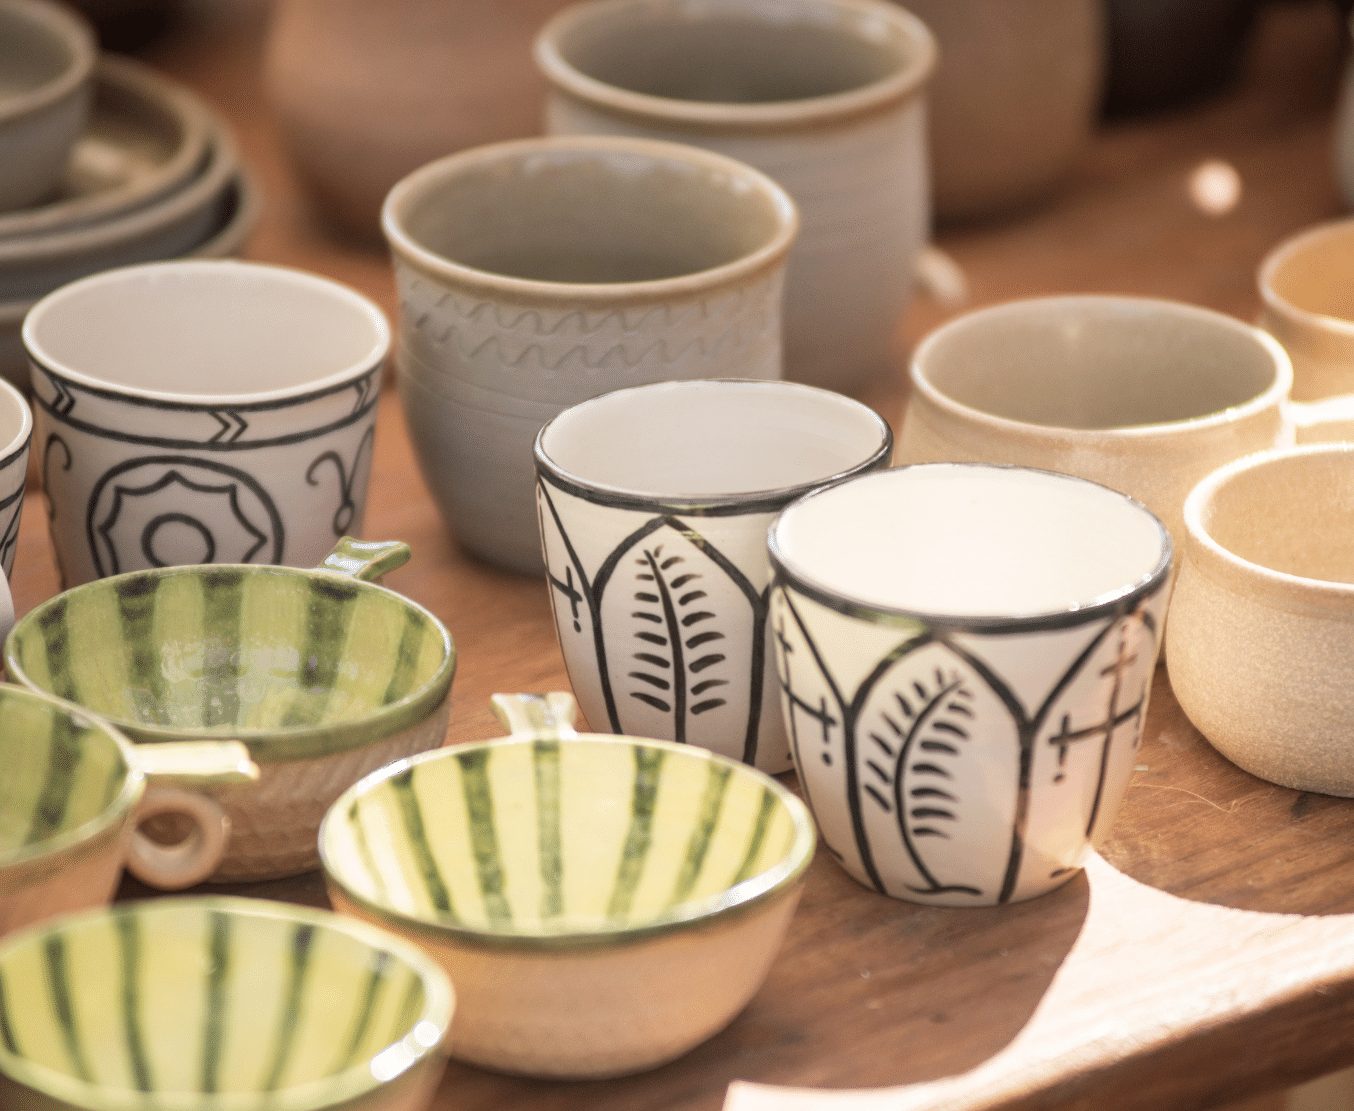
<box><xmin>4</xmin><ymin>563</ymin><xmax>458</xmax><ymax>763</ymax></box>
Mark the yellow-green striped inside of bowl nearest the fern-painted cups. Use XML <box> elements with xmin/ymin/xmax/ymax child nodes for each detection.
<box><xmin>322</xmin><ymin>738</ymin><xmax>795</xmax><ymax>936</ymax></box>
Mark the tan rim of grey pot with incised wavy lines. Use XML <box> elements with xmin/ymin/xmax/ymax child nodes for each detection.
<box><xmin>380</xmin><ymin>135</ymin><xmax>799</xmax><ymax>302</ymax></box>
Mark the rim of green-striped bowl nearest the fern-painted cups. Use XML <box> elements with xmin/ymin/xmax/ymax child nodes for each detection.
<box><xmin>318</xmin><ymin>731</ymin><xmax>818</xmax><ymax>953</ymax></box>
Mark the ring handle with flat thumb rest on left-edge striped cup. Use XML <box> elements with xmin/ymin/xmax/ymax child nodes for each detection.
<box><xmin>127</xmin><ymin>740</ymin><xmax>259</xmax><ymax>890</ymax></box>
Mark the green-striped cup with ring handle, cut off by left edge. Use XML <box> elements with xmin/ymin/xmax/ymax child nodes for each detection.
<box><xmin>0</xmin><ymin>685</ymin><xmax>259</xmax><ymax>936</ymax></box>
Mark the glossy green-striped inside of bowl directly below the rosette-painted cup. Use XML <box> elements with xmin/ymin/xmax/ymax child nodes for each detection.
<box><xmin>5</xmin><ymin>567</ymin><xmax>451</xmax><ymax>740</ymax></box>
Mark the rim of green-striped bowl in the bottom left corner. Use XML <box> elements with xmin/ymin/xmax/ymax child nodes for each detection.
<box><xmin>0</xmin><ymin>894</ymin><xmax>456</xmax><ymax>1111</ymax></box>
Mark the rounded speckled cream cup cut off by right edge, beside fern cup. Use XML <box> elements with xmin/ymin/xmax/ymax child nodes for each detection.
<box><xmin>1167</xmin><ymin>444</ymin><xmax>1354</xmax><ymax>796</ymax></box>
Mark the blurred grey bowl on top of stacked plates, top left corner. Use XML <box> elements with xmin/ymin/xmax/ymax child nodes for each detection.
<box><xmin>0</xmin><ymin>0</ymin><xmax>96</xmax><ymax>212</ymax></box>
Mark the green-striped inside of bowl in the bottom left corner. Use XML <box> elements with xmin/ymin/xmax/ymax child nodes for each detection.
<box><xmin>0</xmin><ymin>900</ymin><xmax>424</xmax><ymax>1107</ymax></box>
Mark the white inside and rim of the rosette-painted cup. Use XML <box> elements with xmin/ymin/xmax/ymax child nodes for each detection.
<box><xmin>23</xmin><ymin>261</ymin><xmax>390</xmax><ymax>402</ymax></box>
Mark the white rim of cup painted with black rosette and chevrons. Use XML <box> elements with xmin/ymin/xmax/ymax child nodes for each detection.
<box><xmin>23</xmin><ymin>258</ymin><xmax>390</xmax><ymax>407</ymax></box>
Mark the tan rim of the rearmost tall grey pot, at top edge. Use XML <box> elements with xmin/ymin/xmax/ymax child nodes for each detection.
<box><xmin>535</xmin><ymin>0</ymin><xmax>938</xmax><ymax>130</ymax></box>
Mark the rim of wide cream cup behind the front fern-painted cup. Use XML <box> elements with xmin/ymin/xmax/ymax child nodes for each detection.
<box><xmin>909</xmin><ymin>294</ymin><xmax>1293</xmax><ymax>444</ymax></box>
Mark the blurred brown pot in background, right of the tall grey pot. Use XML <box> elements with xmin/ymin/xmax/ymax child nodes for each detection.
<box><xmin>903</xmin><ymin>0</ymin><xmax>1105</xmax><ymax>221</ymax></box>
